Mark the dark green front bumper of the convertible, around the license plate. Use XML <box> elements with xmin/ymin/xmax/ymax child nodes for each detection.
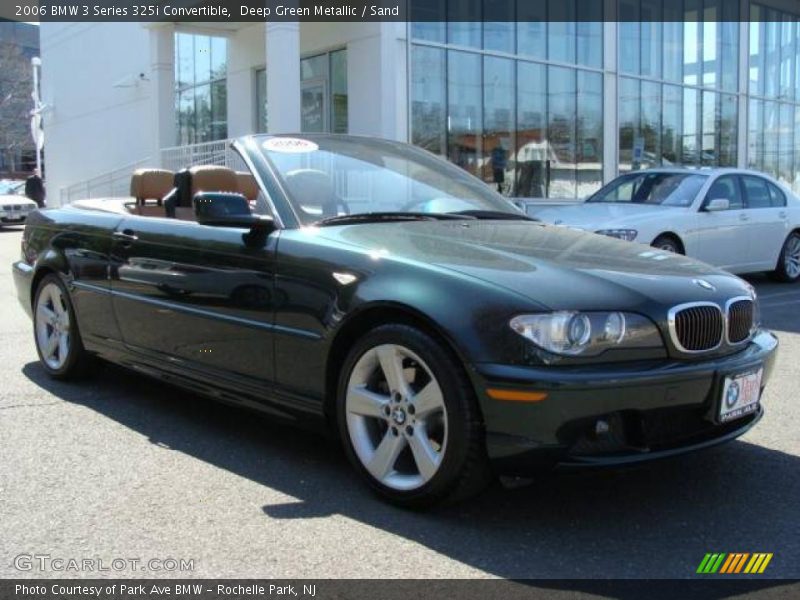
<box><xmin>475</xmin><ymin>331</ymin><xmax>778</xmax><ymax>475</ymax></box>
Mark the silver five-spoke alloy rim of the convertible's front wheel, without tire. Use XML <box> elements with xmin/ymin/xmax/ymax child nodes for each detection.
<box><xmin>345</xmin><ymin>344</ymin><xmax>447</xmax><ymax>490</ymax></box>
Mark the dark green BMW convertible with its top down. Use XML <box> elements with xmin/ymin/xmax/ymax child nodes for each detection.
<box><xmin>14</xmin><ymin>135</ymin><xmax>777</xmax><ymax>506</ymax></box>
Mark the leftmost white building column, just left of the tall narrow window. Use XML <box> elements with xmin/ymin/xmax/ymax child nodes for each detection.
<box><xmin>150</xmin><ymin>23</ymin><xmax>176</xmax><ymax>165</ymax></box>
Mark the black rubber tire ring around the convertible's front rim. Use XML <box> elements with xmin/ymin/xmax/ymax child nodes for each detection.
<box><xmin>336</xmin><ymin>325</ymin><xmax>483</xmax><ymax>508</ymax></box>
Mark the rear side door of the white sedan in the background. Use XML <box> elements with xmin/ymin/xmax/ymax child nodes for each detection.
<box><xmin>741</xmin><ymin>175</ymin><xmax>789</xmax><ymax>270</ymax></box>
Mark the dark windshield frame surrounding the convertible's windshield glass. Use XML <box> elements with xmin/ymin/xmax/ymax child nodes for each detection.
<box><xmin>238</xmin><ymin>133</ymin><xmax>525</xmax><ymax>229</ymax></box>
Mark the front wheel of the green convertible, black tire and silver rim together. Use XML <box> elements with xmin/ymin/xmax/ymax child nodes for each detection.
<box><xmin>336</xmin><ymin>324</ymin><xmax>492</xmax><ymax>508</ymax></box>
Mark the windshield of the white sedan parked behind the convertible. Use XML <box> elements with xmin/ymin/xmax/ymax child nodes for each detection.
<box><xmin>587</xmin><ymin>172</ymin><xmax>708</xmax><ymax>207</ymax></box>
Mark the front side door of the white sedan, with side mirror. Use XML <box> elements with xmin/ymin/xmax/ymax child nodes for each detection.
<box><xmin>695</xmin><ymin>174</ymin><xmax>752</xmax><ymax>271</ymax></box>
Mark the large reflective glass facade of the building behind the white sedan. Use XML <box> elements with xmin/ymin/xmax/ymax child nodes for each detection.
<box><xmin>410</xmin><ymin>0</ymin><xmax>800</xmax><ymax>197</ymax></box>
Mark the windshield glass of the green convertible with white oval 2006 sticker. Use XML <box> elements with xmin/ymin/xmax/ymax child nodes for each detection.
<box><xmin>255</xmin><ymin>135</ymin><xmax>524</xmax><ymax>225</ymax></box>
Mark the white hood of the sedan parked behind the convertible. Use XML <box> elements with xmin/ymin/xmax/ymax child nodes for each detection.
<box><xmin>534</xmin><ymin>202</ymin><xmax>685</xmax><ymax>231</ymax></box>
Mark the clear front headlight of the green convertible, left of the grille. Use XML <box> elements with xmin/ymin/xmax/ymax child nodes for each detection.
<box><xmin>509</xmin><ymin>311</ymin><xmax>663</xmax><ymax>356</ymax></box>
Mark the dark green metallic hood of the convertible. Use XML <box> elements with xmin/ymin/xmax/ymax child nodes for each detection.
<box><xmin>316</xmin><ymin>221</ymin><xmax>751</xmax><ymax>310</ymax></box>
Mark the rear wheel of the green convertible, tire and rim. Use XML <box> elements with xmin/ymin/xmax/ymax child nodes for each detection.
<box><xmin>33</xmin><ymin>274</ymin><xmax>92</xmax><ymax>379</ymax></box>
